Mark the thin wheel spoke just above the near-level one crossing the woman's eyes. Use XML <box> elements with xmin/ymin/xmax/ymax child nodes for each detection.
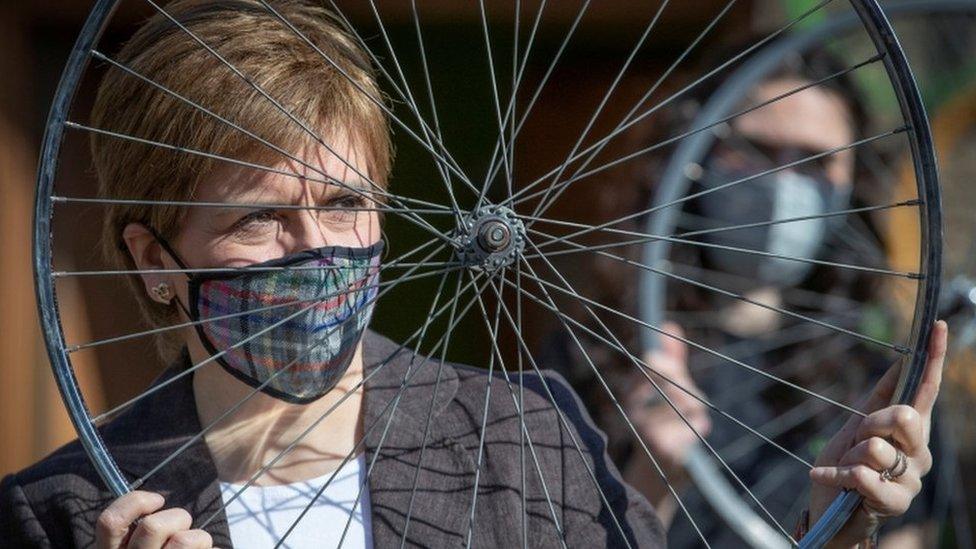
<box><xmin>64</xmin><ymin>121</ymin><xmax>451</xmax><ymax>242</ymax></box>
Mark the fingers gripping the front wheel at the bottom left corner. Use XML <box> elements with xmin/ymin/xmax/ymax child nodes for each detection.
<box><xmin>95</xmin><ymin>490</ymin><xmax>213</xmax><ymax>549</ymax></box>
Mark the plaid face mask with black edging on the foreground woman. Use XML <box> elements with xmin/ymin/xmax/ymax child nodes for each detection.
<box><xmin>152</xmin><ymin>231</ymin><xmax>383</xmax><ymax>404</ymax></box>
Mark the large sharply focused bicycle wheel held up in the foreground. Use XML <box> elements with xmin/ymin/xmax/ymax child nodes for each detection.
<box><xmin>34</xmin><ymin>0</ymin><xmax>941</xmax><ymax>546</ymax></box>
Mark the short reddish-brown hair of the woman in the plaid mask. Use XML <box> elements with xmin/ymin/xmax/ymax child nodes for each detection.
<box><xmin>91</xmin><ymin>0</ymin><xmax>393</xmax><ymax>338</ymax></box>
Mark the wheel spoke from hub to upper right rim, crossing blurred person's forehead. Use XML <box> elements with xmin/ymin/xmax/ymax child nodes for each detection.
<box><xmin>513</xmin><ymin>50</ymin><xmax>884</xmax><ymax>209</ymax></box>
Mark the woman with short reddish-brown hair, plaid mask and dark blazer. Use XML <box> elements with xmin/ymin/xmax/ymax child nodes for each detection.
<box><xmin>0</xmin><ymin>0</ymin><xmax>943</xmax><ymax>548</ymax></box>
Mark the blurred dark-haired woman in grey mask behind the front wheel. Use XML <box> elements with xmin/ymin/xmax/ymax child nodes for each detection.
<box><xmin>547</xmin><ymin>39</ymin><xmax>944</xmax><ymax>547</ymax></box>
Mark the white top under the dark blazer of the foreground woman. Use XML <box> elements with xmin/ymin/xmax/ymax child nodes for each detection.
<box><xmin>220</xmin><ymin>454</ymin><xmax>373</xmax><ymax>549</ymax></box>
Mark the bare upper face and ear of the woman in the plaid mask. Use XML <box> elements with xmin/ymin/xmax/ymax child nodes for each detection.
<box><xmin>129</xmin><ymin>129</ymin><xmax>380</xmax><ymax>326</ymax></box>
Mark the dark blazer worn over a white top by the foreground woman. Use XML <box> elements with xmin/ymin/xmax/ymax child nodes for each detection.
<box><xmin>0</xmin><ymin>332</ymin><xmax>664</xmax><ymax>548</ymax></box>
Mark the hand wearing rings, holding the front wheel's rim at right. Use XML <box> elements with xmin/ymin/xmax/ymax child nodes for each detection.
<box><xmin>810</xmin><ymin>321</ymin><xmax>948</xmax><ymax>547</ymax></box>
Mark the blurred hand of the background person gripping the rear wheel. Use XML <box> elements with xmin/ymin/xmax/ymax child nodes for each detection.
<box><xmin>624</xmin><ymin>322</ymin><xmax>712</xmax><ymax>483</ymax></box>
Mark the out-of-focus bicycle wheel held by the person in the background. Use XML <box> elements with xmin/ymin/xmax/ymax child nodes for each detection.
<box><xmin>641</xmin><ymin>1</ymin><xmax>974</xmax><ymax>547</ymax></box>
